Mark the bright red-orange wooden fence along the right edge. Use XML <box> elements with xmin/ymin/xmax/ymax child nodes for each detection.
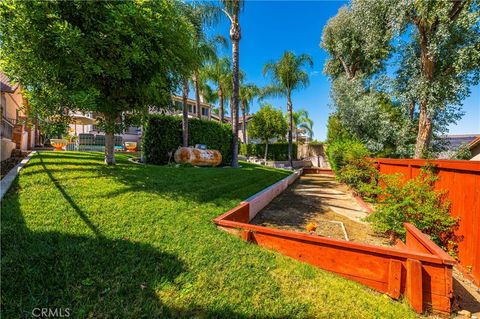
<box><xmin>374</xmin><ymin>158</ymin><xmax>480</xmax><ymax>285</ymax></box>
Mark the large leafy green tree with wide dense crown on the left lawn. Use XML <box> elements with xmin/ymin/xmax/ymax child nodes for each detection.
<box><xmin>0</xmin><ymin>0</ymin><xmax>194</xmax><ymax>164</ymax></box>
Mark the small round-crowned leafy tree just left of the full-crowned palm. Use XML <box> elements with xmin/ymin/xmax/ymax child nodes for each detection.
<box><xmin>248</xmin><ymin>103</ymin><xmax>286</xmax><ymax>167</ymax></box>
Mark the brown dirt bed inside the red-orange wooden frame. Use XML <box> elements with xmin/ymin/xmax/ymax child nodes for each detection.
<box><xmin>250</xmin><ymin>174</ymin><xmax>389</xmax><ymax>246</ymax></box>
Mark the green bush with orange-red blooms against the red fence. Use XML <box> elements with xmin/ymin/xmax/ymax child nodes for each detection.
<box><xmin>367</xmin><ymin>166</ymin><xmax>458</xmax><ymax>256</ymax></box>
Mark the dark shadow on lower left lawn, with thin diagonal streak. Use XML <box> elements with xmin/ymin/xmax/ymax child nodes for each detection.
<box><xmin>1</xmin><ymin>154</ymin><xmax>286</xmax><ymax>318</ymax></box>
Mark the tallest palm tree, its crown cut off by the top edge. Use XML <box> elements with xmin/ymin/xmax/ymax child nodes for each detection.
<box><xmin>222</xmin><ymin>0</ymin><xmax>244</xmax><ymax>168</ymax></box>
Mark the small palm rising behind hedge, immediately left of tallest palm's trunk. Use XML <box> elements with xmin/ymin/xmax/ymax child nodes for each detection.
<box><xmin>204</xmin><ymin>57</ymin><xmax>232</xmax><ymax>123</ymax></box>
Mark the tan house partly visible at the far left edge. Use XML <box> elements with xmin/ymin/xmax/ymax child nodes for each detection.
<box><xmin>0</xmin><ymin>72</ymin><xmax>40</xmax><ymax>161</ymax></box>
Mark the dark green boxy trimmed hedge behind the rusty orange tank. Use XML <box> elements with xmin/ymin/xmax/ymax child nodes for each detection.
<box><xmin>142</xmin><ymin>115</ymin><xmax>233</xmax><ymax>165</ymax></box>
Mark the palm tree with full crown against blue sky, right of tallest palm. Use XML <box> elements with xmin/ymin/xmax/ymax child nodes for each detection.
<box><xmin>263</xmin><ymin>51</ymin><xmax>313</xmax><ymax>167</ymax></box>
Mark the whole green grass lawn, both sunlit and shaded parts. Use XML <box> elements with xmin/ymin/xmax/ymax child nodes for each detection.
<box><xmin>1</xmin><ymin>152</ymin><xmax>415</xmax><ymax>318</ymax></box>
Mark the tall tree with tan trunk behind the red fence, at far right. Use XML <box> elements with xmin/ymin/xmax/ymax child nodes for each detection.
<box><xmin>399</xmin><ymin>0</ymin><xmax>480</xmax><ymax>158</ymax></box>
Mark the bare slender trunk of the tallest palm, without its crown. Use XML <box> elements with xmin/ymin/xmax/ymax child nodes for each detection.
<box><xmin>230</xmin><ymin>14</ymin><xmax>241</xmax><ymax>168</ymax></box>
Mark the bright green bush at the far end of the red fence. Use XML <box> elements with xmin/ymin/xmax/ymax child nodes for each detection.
<box><xmin>326</xmin><ymin>139</ymin><xmax>369</xmax><ymax>174</ymax></box>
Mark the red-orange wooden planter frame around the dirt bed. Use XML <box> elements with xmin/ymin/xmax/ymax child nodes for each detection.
<box><xmin>214</xmin><ymin>170</ymin><xmax>456</xmax><ymax>314</ymax></box>
